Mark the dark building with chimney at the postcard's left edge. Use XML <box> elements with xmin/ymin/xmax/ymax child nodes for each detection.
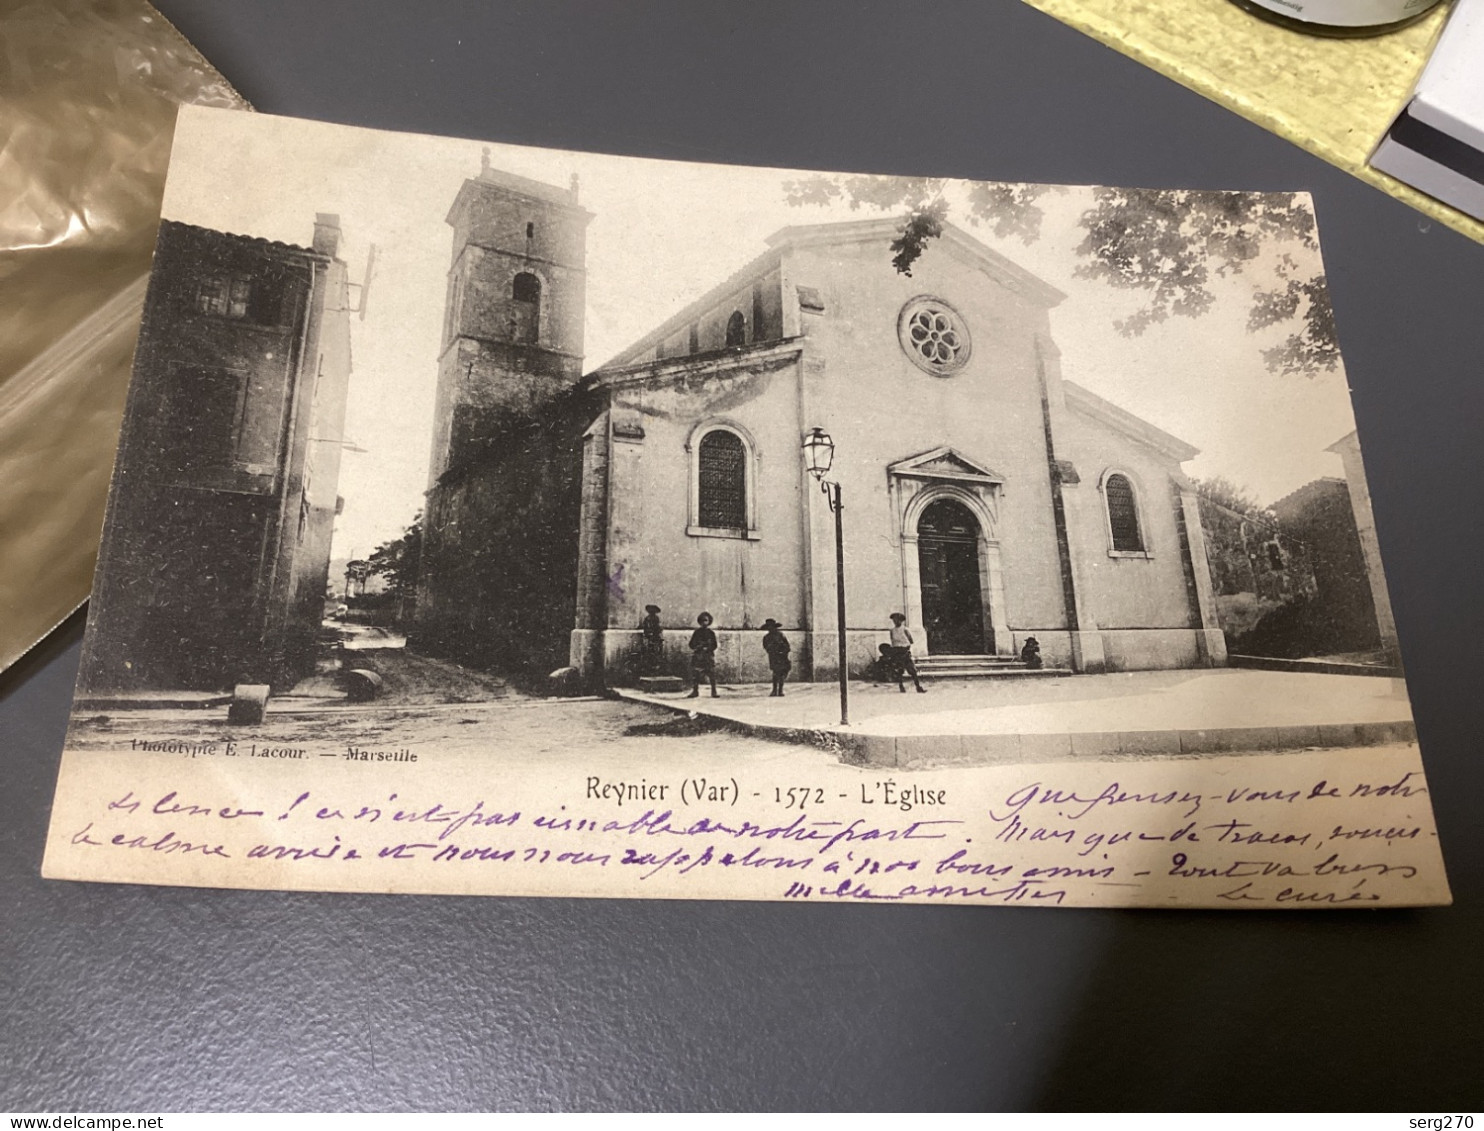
<box><xmin>80</xmin><ymin>215</ymin><xmax>350</xmax><ymax>693</ymax></box>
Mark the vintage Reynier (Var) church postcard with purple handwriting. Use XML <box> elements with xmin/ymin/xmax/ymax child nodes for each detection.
<box><xmin>43</xmin><ymin>107</ymin><xmax>1448</xmax><ymax>908</ymax></box>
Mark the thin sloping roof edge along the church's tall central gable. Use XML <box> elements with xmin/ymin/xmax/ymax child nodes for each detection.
<box><xmin>598</xmin><ymin>217</ymin><xmax>1067</xmax><ymax>370</ymax></box>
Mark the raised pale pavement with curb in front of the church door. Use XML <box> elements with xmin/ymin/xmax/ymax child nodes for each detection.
<box><xmin>620</xmin><ymin>668</ymin><xmax>1417</xmax><ymax>767</ymax></box>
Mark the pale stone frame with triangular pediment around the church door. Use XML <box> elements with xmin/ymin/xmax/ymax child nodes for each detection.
<box><xmin>886</xmin><ymin>447</ymin><xmax>1015</xmax><ymax>656</ymax></box>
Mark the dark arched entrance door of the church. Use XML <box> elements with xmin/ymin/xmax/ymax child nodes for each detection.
<box><xmin>917</xmin><ymin>499</ymin><xmax>994</xmax><ymax>655</ymax></box>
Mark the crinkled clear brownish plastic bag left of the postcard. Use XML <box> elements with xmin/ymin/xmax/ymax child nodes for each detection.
<box><xmin>0</xmin><ymin>0</ymin><xmax>249</xmax><ymax>669</ymax></box>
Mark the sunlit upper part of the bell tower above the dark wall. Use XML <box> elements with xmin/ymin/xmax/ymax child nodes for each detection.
<box><xmin>429</xmin><ymin>150</ymin><xmax>592</xmax><ymax>487</ymax></box>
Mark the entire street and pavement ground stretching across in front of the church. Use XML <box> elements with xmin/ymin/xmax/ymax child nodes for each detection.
<box><xmin>68</xmin><ymin>640</ymin><xmax>1416</xmax><ymax>767</ymax></box>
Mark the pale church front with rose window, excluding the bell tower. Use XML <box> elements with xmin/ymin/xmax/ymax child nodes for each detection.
<box><xmin>570</xmin><ymin>220</ymin><xmax>1226</xmax><ymax>683</ymax></box>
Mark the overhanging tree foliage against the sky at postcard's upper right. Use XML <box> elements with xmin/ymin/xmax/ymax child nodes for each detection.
<box><xmin>784</xmin><ymin>174</ymin><xmax>1340</xmax><ymax>374</ymax></box>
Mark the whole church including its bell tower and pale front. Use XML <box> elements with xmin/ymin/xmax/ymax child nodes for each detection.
<box><xmin>420</xmin><ymin>169</ymin><xmax>1226</xmax><ymax>684</ymax></box>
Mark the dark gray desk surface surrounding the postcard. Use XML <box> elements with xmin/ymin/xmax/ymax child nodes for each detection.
<box><xmin>0</xmin><ymin>0</ymin><xmax>1484</xmax><ymax>1112</ymax></box>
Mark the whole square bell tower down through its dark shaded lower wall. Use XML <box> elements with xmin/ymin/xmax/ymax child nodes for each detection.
<box><xmin>410</xmin><ymin>162</ymin><xmax>591</xmax><ymax>674</ymax></box>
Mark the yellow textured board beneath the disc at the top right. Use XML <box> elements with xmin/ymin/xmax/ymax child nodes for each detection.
<box><xmin>1025</xmin><ymin>0</ymin><xmax>1484</xmax><ymax>243</ymax></box>
